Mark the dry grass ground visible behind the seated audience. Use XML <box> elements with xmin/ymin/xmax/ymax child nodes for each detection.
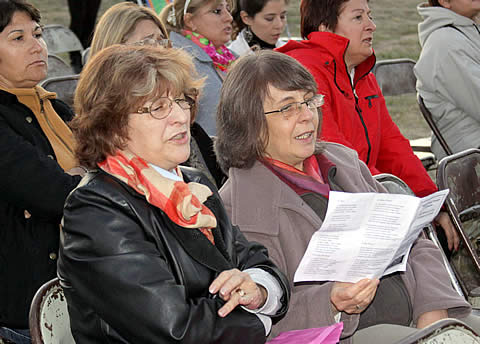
<box><xmin>30</xmin><ymin>0</ymin><xmax>430</xmax><ymax>139</ymax></box>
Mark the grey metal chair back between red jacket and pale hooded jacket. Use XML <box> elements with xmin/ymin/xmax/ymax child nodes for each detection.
<box><xmin>372</xmin><ymin>58</ymin><xmax>417</xmax><ymax>96</ymax></box>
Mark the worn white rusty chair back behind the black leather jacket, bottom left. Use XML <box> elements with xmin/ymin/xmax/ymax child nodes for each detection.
<box><xmin>29</xmin><ymin>278</ymin><xmax>75</xmax><ymax>344</ymax></box>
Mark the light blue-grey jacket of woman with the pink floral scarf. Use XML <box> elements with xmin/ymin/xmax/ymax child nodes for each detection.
<box><xmin>170</xmin><ymin>31</ymin><xmax>223</xmax><ymax>136</ymax></box>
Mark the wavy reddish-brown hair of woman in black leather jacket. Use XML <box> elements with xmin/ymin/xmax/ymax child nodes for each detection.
<box><xmin>70</xmin><ymin>44</ymin><xmax>203</xmax><ymax>168</ymax></box>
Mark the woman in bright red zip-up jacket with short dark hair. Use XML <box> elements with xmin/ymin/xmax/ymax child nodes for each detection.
<box><xmin>277</xmin><ymin>0</ymin><xmax>459</xmax><ymax>249</ymax></box>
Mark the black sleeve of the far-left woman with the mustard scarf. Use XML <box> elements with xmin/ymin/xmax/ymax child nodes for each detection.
<box><xmin>0</xmin><ymin>103</ymin><xmax>80</xmax><ymax>221</ymax></box>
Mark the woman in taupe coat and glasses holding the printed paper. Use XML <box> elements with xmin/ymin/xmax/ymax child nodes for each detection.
<box><xmin>215</xmin><ymin>50</ymin><xmax>480</xmax><ymax>343</ymax></box>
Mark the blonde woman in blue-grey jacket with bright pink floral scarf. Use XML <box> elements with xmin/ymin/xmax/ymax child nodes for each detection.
<box><xmin>160</xmin><ymin>0</ymin><xmax>235</xmax><ymax>136</ymax></box>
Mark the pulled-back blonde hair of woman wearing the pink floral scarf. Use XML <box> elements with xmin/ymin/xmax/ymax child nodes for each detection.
<box><xmin>160</xmin><ymin>0</ymin><xmax>233</xmax><ymax>32</ymax></box>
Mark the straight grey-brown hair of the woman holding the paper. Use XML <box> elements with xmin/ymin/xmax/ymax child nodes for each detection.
<box><xmin>215</xmin><ymin>50</ymin><xmax>317</xmax><ymax>172</ymax></box>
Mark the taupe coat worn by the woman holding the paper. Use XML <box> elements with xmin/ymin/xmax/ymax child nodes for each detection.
<box><xmin>220</xmin><ymin>143</ymin><xmax>470</xmax><ymax>342</ymax></box>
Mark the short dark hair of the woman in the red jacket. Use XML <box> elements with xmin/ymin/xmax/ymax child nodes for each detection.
<box><xmin>300</xmin><ymin>0</ymin><xmax>352</xmax><ymax>39</ymax></box>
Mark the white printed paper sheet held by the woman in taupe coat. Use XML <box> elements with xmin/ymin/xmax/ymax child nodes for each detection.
<box><xmin>294</xmin><ymin>190</ymin><xmax>448</xmax><ymax>283</ymax></box>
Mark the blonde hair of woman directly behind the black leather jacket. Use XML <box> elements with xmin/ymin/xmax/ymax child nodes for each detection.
<box><xmin>90</xmin><ymin>2</ymin><xmax>168</xmax><ymax>59</ymax></box>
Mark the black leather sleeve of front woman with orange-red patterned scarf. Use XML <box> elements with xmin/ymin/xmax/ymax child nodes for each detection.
<box><xmin>59</xmin><ymin>181</ymin><xmax>266</xmax><ymax>344</ymax></box>
